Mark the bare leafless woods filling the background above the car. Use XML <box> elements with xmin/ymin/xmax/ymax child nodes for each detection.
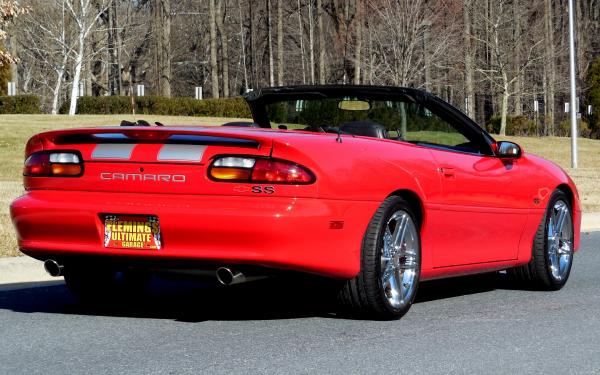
<box><xmin>0</xmin><ymin>0</ymin><xmax>600</xmax><ymax>135</ymax></box>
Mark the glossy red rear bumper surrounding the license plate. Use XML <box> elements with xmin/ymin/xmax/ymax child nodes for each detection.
<box><xmin>11</xmin><ymin>190</ymin><xmax>378</xmax><ymax>278</ymax></box>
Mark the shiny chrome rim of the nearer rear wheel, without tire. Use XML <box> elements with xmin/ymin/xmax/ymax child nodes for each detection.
<box><xmin>381</xmin><ymin>210</ymin><xmax>420</xmax><ymax>309</ymax></box>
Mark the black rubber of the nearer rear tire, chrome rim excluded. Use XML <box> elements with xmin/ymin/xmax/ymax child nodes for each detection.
<box><xmin>338</xmin><ymin>196</ymin><xmax>421</xmax><ymax>320</ymax></box>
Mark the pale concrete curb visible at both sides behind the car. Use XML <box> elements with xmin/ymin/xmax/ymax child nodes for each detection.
<box><xmin>0</xmin><ymin>212</ymin><xmax>600</xmax><ymax>290</ymax></box>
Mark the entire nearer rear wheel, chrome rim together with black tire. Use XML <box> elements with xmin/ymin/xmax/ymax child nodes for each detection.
<box><xmin>339</xmin><ymin>195</ymin><xmax>421</xmax><ymax>319</ymax></box>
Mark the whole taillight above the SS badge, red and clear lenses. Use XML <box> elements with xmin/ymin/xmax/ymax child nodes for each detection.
<box><xmin>208</xmin><ymin>156</ymin><xmax>315</xmax><ymax>184</ymax></box>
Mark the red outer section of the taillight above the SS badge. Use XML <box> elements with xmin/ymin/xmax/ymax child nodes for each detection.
<box><xmin>252</xmin><ymin>159</ymin><xmax>314</xmax><ymax>184</ymax></box>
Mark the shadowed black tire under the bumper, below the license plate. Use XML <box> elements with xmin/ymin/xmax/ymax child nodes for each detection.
<box><xmin>64</xmin><ymin>263</ymin><xmax>150</xmax><ymax>304</ymax></box>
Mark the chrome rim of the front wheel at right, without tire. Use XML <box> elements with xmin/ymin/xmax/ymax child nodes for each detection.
<box><xmin>547</xmin><ymin>200</ymin><xmax>573</xmax><ymax>281</ymax></box>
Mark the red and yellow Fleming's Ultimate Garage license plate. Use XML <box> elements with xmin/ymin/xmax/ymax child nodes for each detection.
<box><xmin>104</xmin><ymin>215</ymin><xmax>161</xmax><ymax>250</ymax></box>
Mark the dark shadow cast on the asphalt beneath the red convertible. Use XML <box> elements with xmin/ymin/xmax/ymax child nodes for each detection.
<box><xmin>0</xmin><ymin>274</ymin><xmax>524</xmax><ymax>322</ymax></box>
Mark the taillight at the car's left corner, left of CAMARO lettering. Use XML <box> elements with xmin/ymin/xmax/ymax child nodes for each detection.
<box><xmin>23</xmin><ymin>151</ymin><xmax>83</xmax><ymax>177</ymax></box>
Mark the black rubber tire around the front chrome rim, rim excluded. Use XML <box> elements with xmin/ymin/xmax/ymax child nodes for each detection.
<box><xmin>507</xmin><ymin>190</ymin><xmax>574</xmax><ymax>291</ymax></box>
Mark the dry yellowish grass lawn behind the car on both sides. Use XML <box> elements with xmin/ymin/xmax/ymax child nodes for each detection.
<box><xmin>0</xmin><ymin>115</ymin><xmax>600</xmax><ymax>256</ymax></box>
